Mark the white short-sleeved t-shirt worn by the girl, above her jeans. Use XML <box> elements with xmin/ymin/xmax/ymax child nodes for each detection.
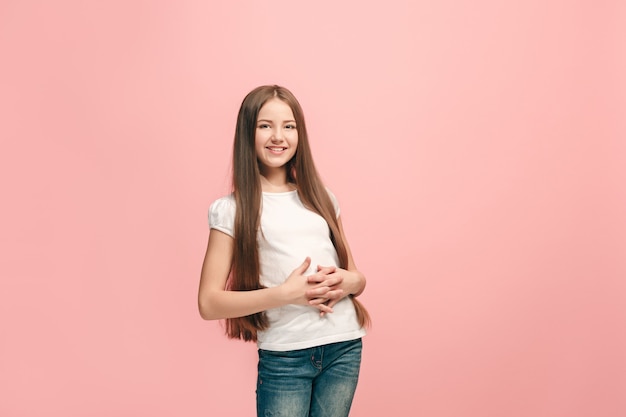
<box><xmin>209</xmin><ymin>191</ymin><xmax>365</xmax><ymax>351</ymax></box>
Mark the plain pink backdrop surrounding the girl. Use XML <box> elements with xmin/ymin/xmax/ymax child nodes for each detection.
<box><xmin>0</xmin><ymin>0</ymin><xmax>626</xmax><ymax>417</ymax></box>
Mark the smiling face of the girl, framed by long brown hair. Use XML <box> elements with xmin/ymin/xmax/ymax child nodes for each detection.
<box><xmin>254</xmin><ymin>97</ymin><xmax>298</xmax><ymax>174</ymax></box>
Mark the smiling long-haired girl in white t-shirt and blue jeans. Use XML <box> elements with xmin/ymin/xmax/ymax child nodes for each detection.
<box><xmin>198</xmin><ymin>85</ymin><xmax>369</xmax><ymax>417</ymax></box>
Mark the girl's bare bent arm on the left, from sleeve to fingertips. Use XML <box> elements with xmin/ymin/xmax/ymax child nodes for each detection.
<box><xmin>198</xmin><ymin>229</ymin><xmax>343</xmax><ymax>320</ymax></box>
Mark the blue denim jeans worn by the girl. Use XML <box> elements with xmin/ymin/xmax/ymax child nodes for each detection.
<box><xmin>256</xmin><ymin>339</ymin><xmax>363</xmax><ymax>417</ymax></box>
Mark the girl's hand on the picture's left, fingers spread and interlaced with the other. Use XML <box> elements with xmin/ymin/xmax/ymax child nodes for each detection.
<box><xmin>281</xmin><ymin>256</ymin><xmax>343</xmax><ymax>313</ymax></box>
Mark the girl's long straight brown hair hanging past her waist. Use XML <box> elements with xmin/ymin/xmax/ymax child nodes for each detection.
<box><xmin>226</xmin><ymin>85</ymin><xmax>370</xmax><ymax>341</ymax></box>
